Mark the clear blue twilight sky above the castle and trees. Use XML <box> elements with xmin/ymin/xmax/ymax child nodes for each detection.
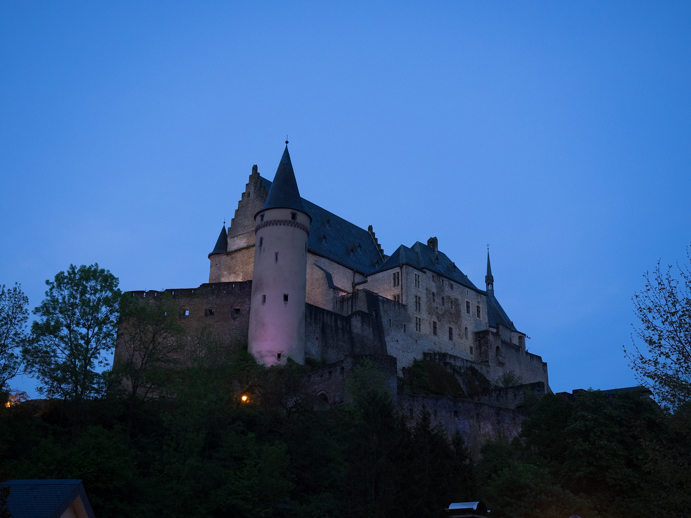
<box><xmin>0</xmin><ymin>0</ymin><xmax>691</xmax><ymax>394</ymax></box>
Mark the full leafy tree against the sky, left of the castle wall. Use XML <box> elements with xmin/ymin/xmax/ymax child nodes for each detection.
<box><xmin>23</xmin><ymin>264</ymin><xmax>120</xmax><ymax>401</ymax></box>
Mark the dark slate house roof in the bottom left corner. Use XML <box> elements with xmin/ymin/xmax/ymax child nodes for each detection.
<box><xmin>0</xmin><ymin>479</ymin><xmax>94</xmax><ymax>518</ymax></box>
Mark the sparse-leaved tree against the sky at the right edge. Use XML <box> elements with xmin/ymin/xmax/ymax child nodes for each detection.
<box><xmin>624</xmin><ymin>246</ymin><xmax>691</xmax><ymax>411</ymax></box>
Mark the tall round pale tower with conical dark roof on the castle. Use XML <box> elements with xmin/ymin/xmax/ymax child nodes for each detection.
<box><xmin>248</xmin><ymin>142</ymin><xmax>312</xmax><ymax>365</ymax></box>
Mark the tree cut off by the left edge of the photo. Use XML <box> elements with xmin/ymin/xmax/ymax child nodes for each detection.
<box><xmin>0</xmin><ymin>284</ymin><xmax>29</xmax><ymax>392</ymax></box>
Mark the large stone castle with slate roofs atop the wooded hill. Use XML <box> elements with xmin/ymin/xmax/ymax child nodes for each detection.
<box><xmin>123</xmin><ymin>142</ymin><xmax>549</xmax><ymax>450</ymax></box>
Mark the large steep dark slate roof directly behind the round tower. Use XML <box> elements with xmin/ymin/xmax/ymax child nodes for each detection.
<box><xmin>262</xmin><ymin>177</ymin><xmax>384</xmax><ymax>274</ymax></box>
